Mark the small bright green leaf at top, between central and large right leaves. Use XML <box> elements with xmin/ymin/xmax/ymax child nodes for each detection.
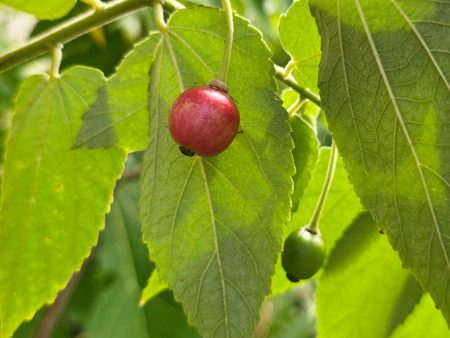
<box><xmin>279</xmin><ymin>0</ymin><xmax>321</xmax><ymax>93</ymax></box>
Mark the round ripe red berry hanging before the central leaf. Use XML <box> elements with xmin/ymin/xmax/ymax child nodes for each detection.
<box><xmin>169</xmin><ymin>85</ymin><xmax>240</xmax><ymax>157</ymax></box>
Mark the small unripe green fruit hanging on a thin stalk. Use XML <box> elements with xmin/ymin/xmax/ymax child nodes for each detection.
<box><xmin>281</xmin><ymin>227</ymin><xmax>326</xmax><ymax>282</ymax></box>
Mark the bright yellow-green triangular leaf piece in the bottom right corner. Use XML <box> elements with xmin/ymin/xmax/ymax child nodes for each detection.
<box><xmin>390</xmin><ymin>294</ymin><xmax>448</xmax><ymax>338</ymax></box>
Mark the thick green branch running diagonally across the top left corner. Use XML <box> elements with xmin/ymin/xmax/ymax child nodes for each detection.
<box><xmin>0</xmin><ymin>0</ymin><xmax>159</xmax><ymax>73</ymax></box>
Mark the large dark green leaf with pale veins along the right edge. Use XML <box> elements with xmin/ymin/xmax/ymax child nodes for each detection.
<box><xmin>311</xmin><ymin>0</ymin><xmax>450</xmax><ymax>322</ymax></box>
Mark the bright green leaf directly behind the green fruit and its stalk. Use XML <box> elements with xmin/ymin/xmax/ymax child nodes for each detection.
<box><xmin>272</xmin><ymin>147</ymin><xmax>362</xmax><ymax>294</ymax></box>
